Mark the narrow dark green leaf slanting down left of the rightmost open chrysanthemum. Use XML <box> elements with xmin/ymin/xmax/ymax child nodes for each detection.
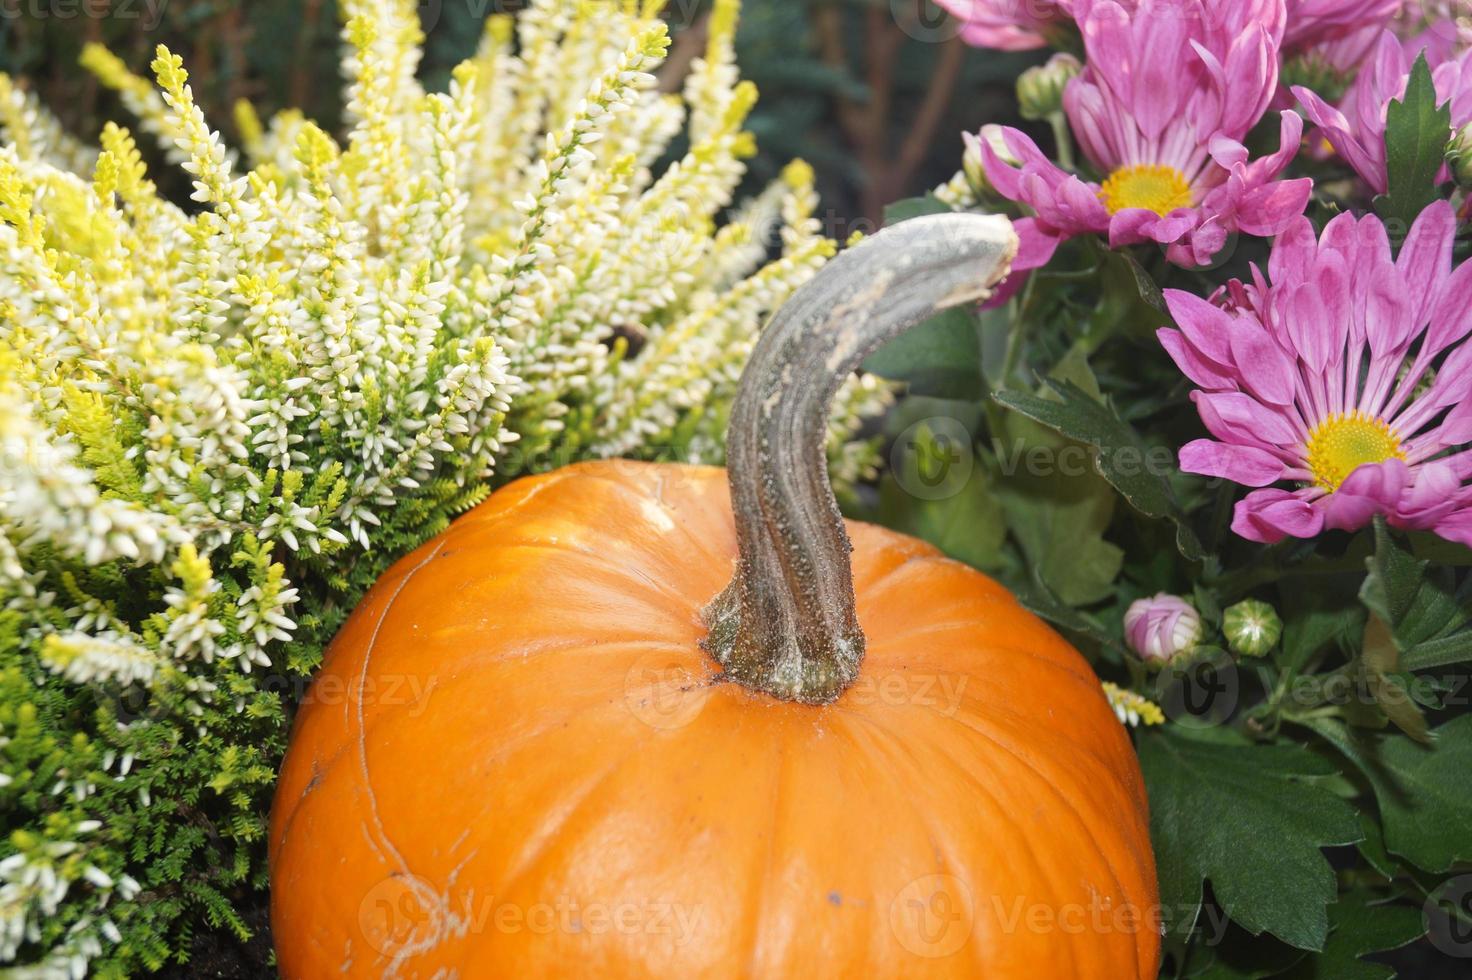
<box><xmin>992</xmin><ymin>380</ymin><xmax>1203</xmax><ymax>561</ymax></box>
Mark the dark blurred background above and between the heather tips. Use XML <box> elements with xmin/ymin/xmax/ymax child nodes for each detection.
<box><xmin>0</xmin><ymin>0</ymin><xmax>1038</xmax><ymax>223</ymax></box>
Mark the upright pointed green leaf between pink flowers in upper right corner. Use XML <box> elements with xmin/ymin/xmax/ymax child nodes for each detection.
<box><xmin>1375</xmin><ymin>53</ymin><xmax>1451</xmax><ymax>234</ymax></box>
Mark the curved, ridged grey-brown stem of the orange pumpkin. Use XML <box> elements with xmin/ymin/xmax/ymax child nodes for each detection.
<box><xmin>704</xmin><ymin>213</ymin><xmax>1017</xmax><ymax>705</ymax></box>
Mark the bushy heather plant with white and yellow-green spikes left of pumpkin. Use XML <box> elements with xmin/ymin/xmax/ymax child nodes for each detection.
<box><xmin>0</xmin><ymin>0</ymin><xmax>885</xmax><ymax>977</ymax></box>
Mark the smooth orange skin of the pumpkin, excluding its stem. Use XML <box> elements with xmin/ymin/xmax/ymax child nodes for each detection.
<box><xmin>269</xmin><ymin>462</ymin><xmax>1160</xmax><ymax>980</ymax></box>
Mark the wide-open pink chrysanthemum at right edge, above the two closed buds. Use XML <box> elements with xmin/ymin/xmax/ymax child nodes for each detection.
<box><xmin>1160</xmin><ymin>202</ymin><xmax>1472</xmax><ymax>544</ymax></box>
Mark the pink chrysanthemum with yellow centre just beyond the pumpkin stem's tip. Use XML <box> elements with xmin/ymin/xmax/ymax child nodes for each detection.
<box><xmin>982</xmin><ymin>0</ymin><xmax>1312</xmax><ymax>280</ymax></box>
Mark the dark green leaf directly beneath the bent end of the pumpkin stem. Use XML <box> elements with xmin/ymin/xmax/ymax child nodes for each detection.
<box><xmin>864</xmin><ymin>308</ymin><xmax>985</xmax><ymax>399</ymax></box>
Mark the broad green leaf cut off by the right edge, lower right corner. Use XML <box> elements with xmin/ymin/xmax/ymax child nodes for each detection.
<box><xmin>1309</xmin><ymin>715</ymin><xmax>1472</xmax><ymax>871</ymax></box>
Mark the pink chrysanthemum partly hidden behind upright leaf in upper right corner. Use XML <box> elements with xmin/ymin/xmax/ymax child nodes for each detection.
<box><xmin>1292</xmin><ymin>31</ymin><xmax>1472</xmax><ymax>194</ymax></box>
